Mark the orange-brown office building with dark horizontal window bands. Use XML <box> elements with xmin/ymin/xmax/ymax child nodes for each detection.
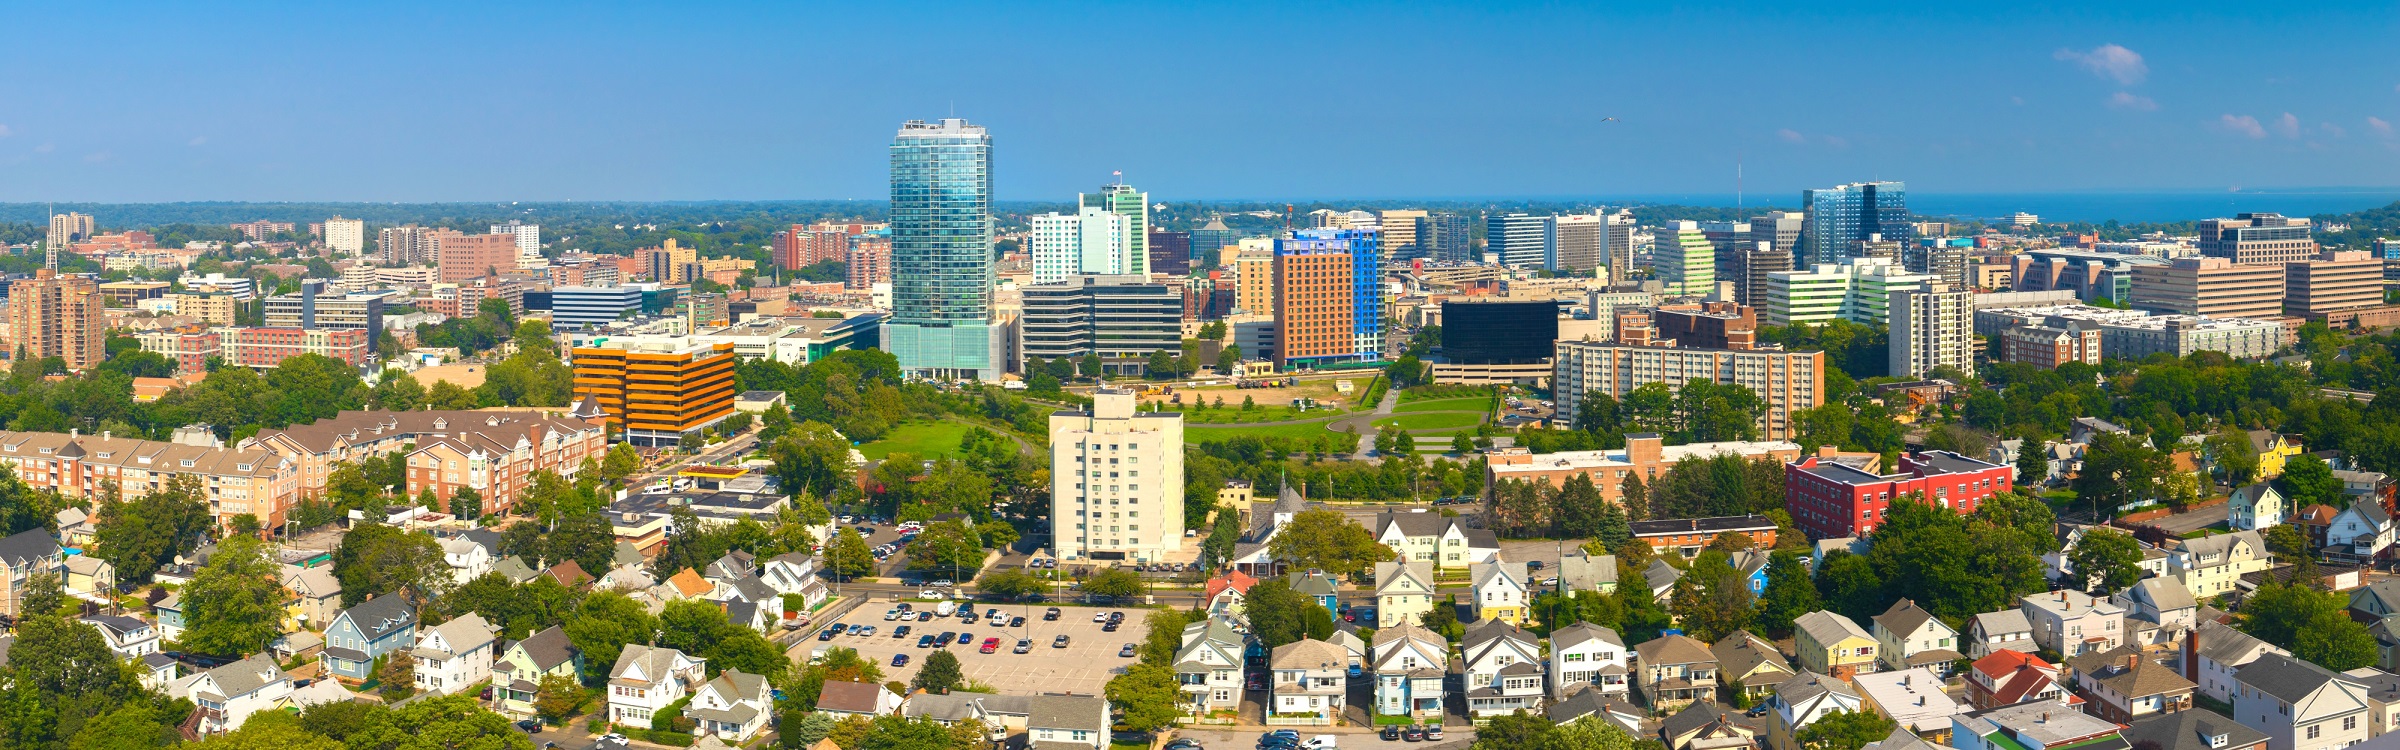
<box><xmin>571</xmin><ymin>341</ymin><xmax>734</xmax><ymax>447</ymax></box>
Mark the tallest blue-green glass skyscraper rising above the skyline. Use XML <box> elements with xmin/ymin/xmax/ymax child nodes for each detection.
<box><xmin>883</xmin><ymin>118</ymin><xmax>1006</xmax><ymax>380</ymax></box>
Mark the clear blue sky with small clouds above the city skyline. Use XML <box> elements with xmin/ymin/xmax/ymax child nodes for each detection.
<box><xmin>0</xmin><ymin>2</ymin><xmax>2400</xmax><ymax>202</ymax></box>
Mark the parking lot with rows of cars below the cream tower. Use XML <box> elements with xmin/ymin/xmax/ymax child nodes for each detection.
<box><xmin>794</xmin><ymin>601</ymin><xmax>1150</xmax><ymax>695</ymax></box>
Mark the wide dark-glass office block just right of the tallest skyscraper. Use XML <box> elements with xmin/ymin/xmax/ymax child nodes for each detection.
<box><xmin>1018</xmin><ymin>276</ymin><xmax>1183</xmax><ymax>375</ymax></box>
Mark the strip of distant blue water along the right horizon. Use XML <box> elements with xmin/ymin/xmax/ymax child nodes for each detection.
<box><xmin>1603</xmin><ymin>188</ymin><xmax>2400</xmax><ymax>224</ymax></box>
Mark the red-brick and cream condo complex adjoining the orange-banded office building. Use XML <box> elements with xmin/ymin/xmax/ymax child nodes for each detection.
<box><xmin>240</xmin><ymin>411</ymin><xmax>607</xmax><ymax>507</ymax></box>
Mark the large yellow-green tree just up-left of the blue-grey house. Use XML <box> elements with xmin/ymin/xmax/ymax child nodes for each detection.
<box><xmin>182</xmin><ymin>536</ymin><xmax>283</xmax><ymax>656</ymax></box>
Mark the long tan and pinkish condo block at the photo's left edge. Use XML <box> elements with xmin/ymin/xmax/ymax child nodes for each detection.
<box><xmin>0</xmin><ymin>433</ymin><xmax>300</xmax><ymax>529</ymax></box>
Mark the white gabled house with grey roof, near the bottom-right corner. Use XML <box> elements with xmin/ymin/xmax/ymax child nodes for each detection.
<box><xmin>2234</xmin><ymin>654</ymin><xmax>2374</xmax><ymax>750</ymax></box>
